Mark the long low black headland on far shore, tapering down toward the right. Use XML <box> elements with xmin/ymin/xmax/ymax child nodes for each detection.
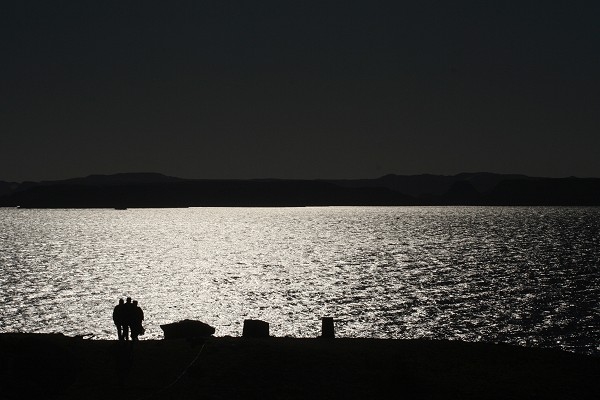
<box><xmin>0</xmin><ymin>180</ymin><xmax>415</xmax><ymax>208</ymax></box>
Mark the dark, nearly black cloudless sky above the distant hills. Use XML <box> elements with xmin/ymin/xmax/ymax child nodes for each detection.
<box><xmin>0</xmin><ymin>0</ymin><xmax>600</xmax><ymax>181</ymax></box>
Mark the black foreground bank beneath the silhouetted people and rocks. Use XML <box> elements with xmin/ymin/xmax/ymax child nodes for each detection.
<box><xmin>0</xmin><ymin>334</ymin><xmax>600</xmax><ymax>400</ymax></box>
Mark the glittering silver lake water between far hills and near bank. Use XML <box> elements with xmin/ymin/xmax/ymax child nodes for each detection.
<box><xmin>0</xmin><ymin>207</ymin><xmax>600</xmax><ymax>354</ymax></box>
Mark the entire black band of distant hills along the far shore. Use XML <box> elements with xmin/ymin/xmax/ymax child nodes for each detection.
<box><xmin>0</xmin><ymin>173</ymin><xmax>600</xmax><ymax>208</ymax></box>
